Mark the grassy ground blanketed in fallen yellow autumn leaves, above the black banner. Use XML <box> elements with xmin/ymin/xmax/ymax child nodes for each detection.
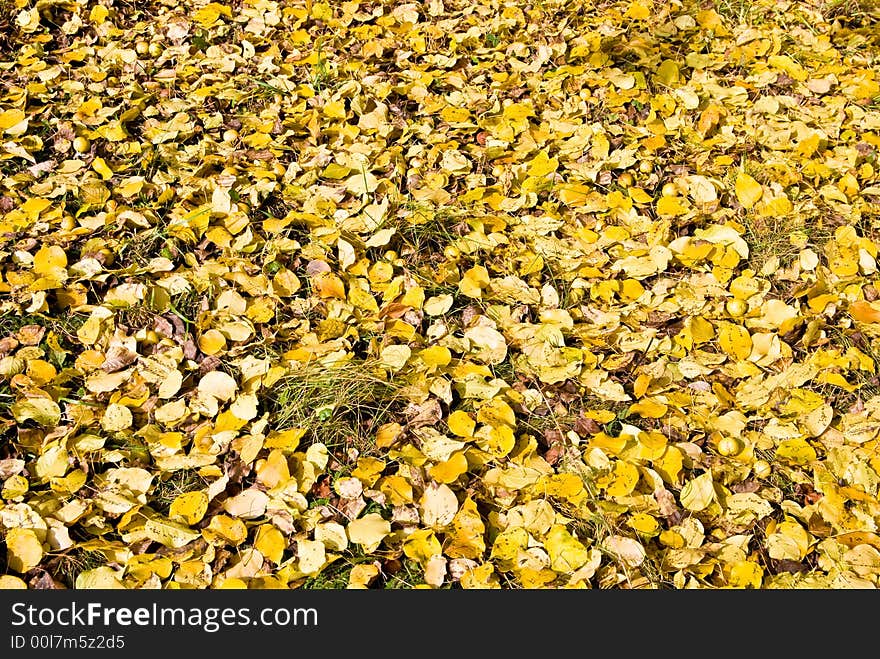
<box><xmin>0</xmin><ymin>0</ymin><xmax>880</xmax><ymax>588</ymax></box>
